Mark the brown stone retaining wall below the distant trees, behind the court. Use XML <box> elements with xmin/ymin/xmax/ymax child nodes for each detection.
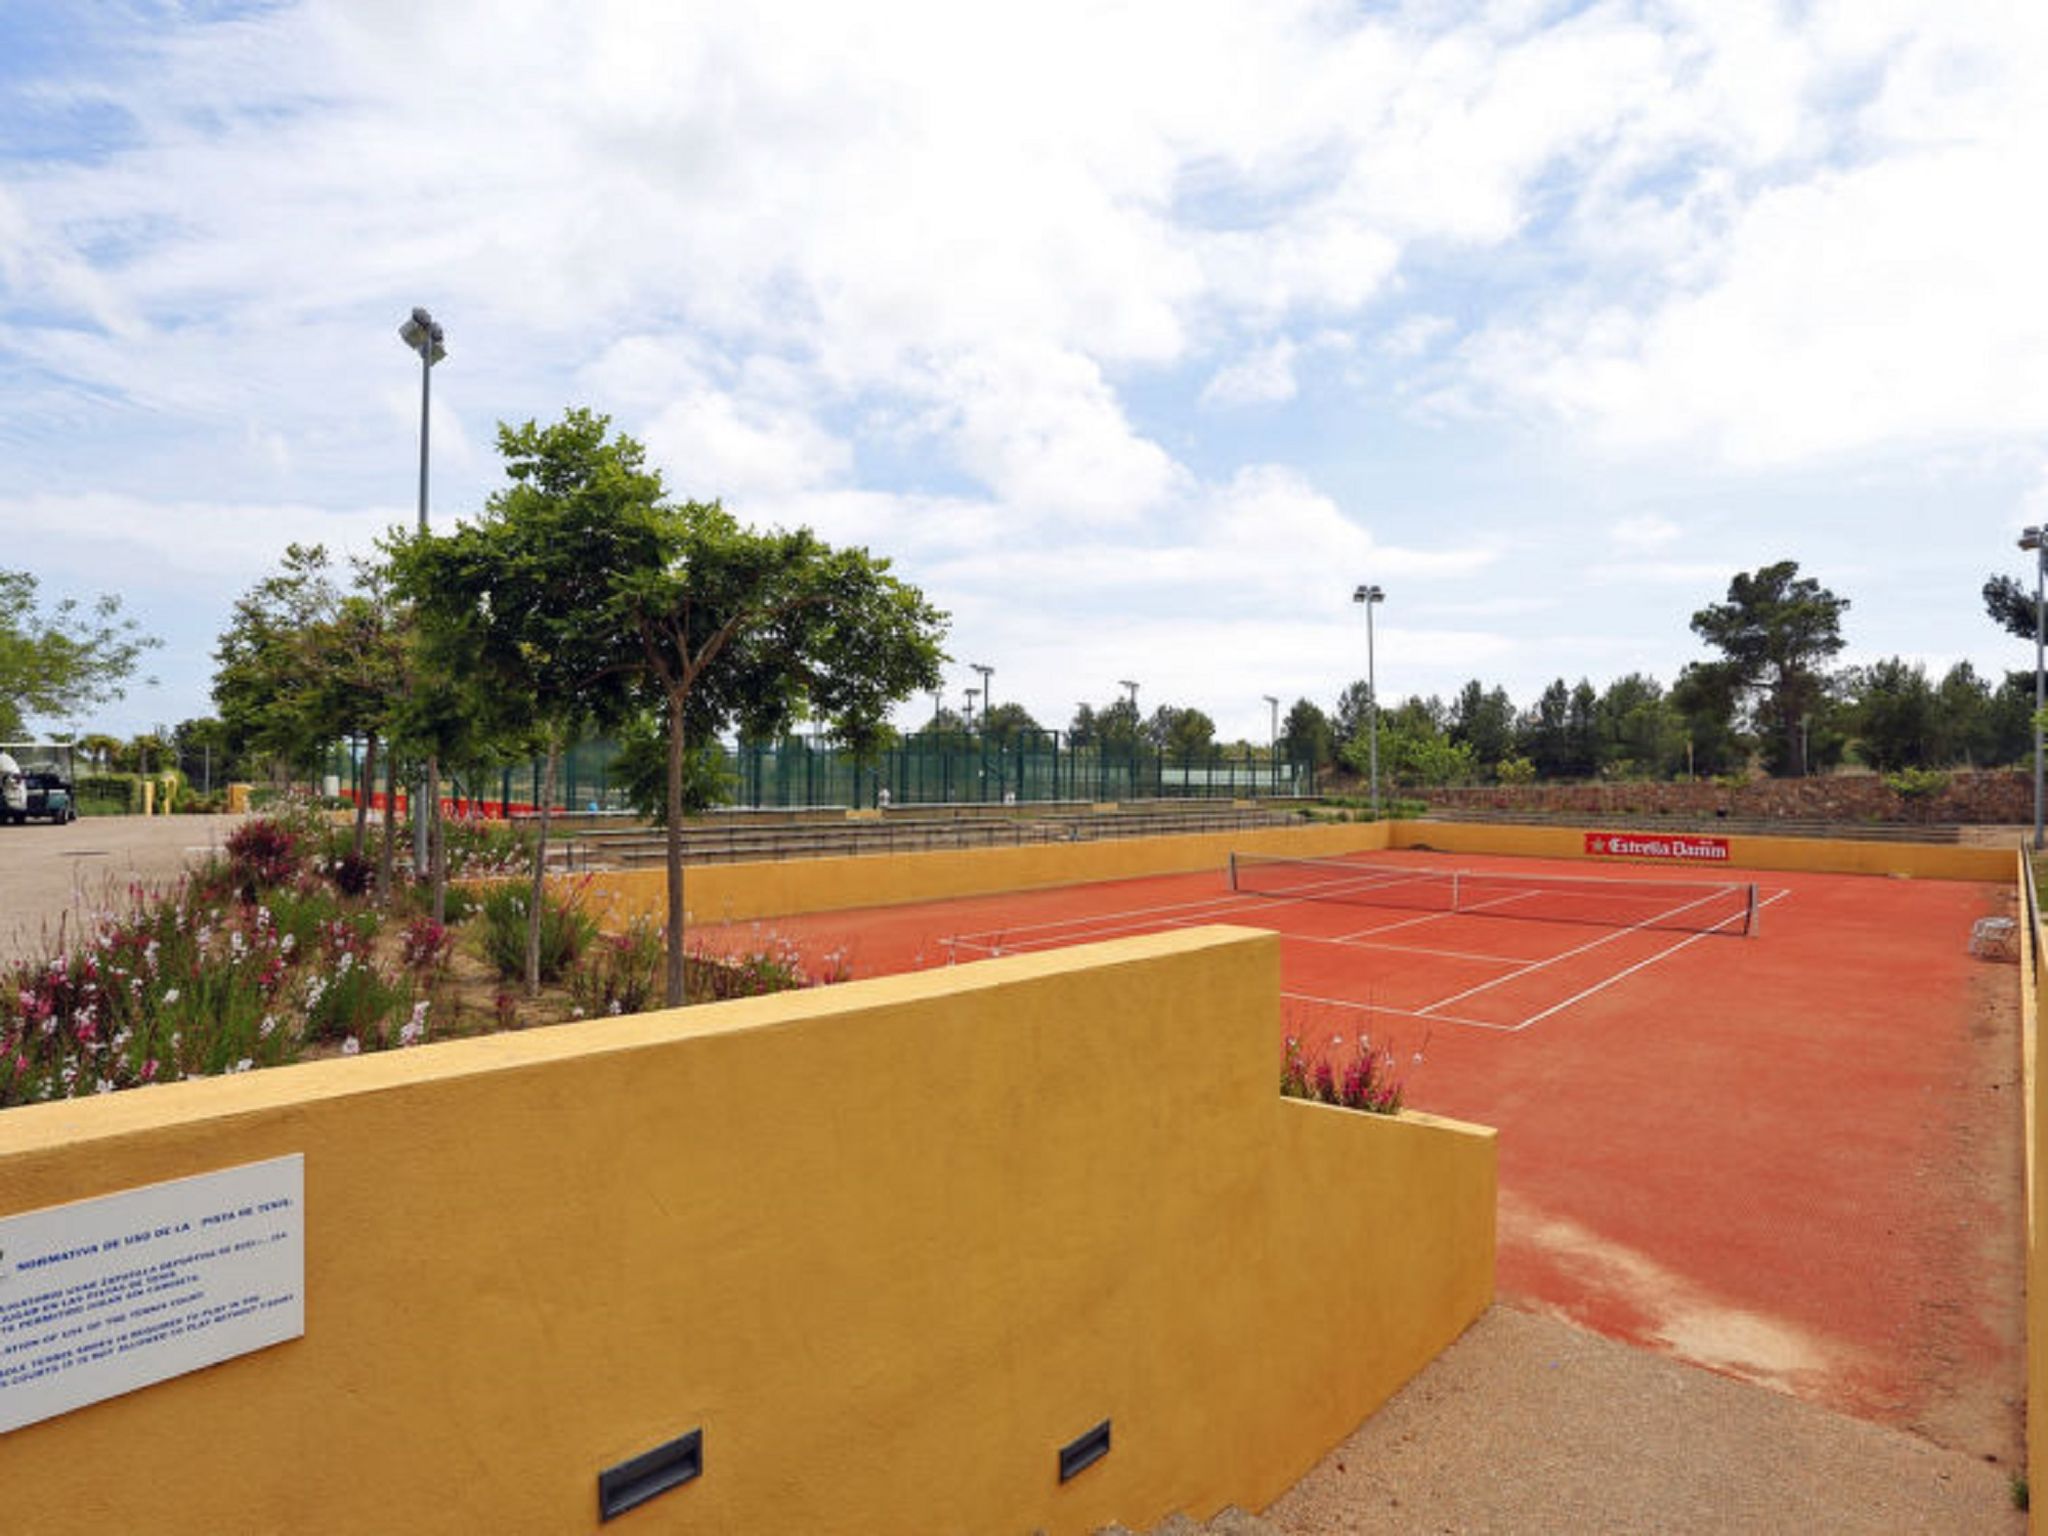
<box><xmin>1427</xmin><ymin>770</ymin><xmax>2034</xmax><ymax>823</ymax></box>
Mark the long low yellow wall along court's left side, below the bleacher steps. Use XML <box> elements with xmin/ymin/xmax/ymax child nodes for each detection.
<box><xmin>575</xmin><ymin>821</ymin><xmax>1386</xmax><ymax>922</ymax></box>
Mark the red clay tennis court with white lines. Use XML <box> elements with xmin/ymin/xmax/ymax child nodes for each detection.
<box><xmin>698</xmin><ymin>850</ymin><xmax>2023</xmax><ymax>1464</ymax></box>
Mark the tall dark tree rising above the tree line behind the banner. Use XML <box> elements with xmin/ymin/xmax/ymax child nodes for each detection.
<box><xmin>1692</xmin><ymin>559</ymin><xmax>1849</xmax><ymax>776</ymax></box>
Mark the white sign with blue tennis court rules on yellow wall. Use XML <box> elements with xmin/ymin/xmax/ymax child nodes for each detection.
<box><xmin>0</xmin><ymin>1153</ymin><xmax>305</xmax><ymax>1434</ymax></box>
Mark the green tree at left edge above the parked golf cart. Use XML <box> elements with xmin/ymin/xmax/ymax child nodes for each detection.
<box><xmin>0</xmin><ymin>569</ymin><xmax>162</xmax><ymax>741</ymax></box>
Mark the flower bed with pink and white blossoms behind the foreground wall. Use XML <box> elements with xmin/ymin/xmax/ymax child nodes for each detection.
<box><xmin>0</xmin><ymin>798</ymin><xmax>840</xmax><ymax>1108</ymax></box>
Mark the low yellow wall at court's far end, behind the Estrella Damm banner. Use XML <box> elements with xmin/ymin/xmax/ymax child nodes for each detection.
<box><xmin>1389</xmin><ymin>821</ymin><xmax>2013</xmax><ymax>881</ymax></box>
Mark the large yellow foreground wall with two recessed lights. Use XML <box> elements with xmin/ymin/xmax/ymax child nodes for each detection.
<box><xmin>0</xmin><ymin>928</ymin><xmax>1495</xmax><ymax>1536</ymax></box>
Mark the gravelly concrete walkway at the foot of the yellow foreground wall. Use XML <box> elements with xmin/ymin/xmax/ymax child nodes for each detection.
<box><xmin>1264</xmin><ymin>1307</ymin><xmax>2025</xmax><ymax>1536</ymax></box>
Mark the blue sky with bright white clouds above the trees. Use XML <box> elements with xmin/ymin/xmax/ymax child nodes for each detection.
<box><xmin>0</xmin><ymin>0</ymin><xmax>2048</xmax><ymax>739</ymax></box>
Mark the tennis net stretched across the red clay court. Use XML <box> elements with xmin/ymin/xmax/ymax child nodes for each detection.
<box><xmin>1231</xmin><ymin>854</ymin><xmax>1757</xmax><ymax>934</ymax></box>
